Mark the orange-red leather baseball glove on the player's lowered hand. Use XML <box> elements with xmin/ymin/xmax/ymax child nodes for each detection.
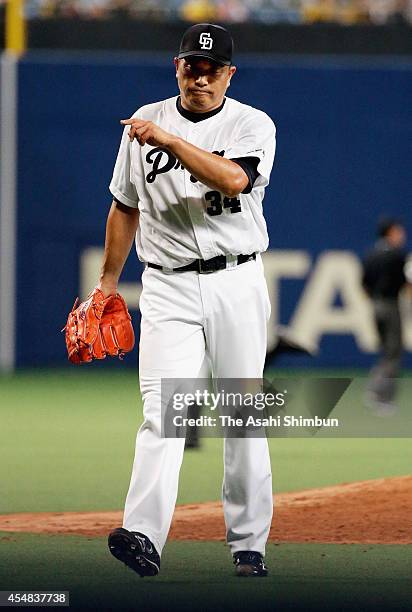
<box><xmin>62</xmin><ymin>287</ymin><xmax>134</xmax><ymax>364</ymax></box>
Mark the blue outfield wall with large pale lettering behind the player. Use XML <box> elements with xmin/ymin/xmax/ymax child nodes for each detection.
<box><xmin>17</xmin><ymin>52</ymin><xmax>412</xmax><ymax>367</ymax></box>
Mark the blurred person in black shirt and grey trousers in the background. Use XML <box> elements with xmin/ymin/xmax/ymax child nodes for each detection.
<box><xmin>362</xmin><ymin>219</ymin><xmax>408</xmax><ymax>414</ymax></box>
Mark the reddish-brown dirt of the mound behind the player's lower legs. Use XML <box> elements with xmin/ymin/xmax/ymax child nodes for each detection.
<box><xmin>0</xmin><ymin>476</ymin><xmax>412</xmax><ymax>544</ymax></box>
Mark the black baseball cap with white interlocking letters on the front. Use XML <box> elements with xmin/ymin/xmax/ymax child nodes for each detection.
<box><xmin>177</xmin><ymin>23</ymin><xmax>233</xmax><ymax>66</ymax></box>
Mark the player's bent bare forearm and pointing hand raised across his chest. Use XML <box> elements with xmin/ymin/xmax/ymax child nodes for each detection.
<box><xmin>121</xmin><ymin>118</ymin><xmax>249</xmax><ymax>198</ymax></box>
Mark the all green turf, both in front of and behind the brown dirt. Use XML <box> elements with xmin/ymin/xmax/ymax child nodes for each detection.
<box><xmin>0</xmin><ymin>367</ymin><xmax>412</xmax><ymax>612</ymax></box>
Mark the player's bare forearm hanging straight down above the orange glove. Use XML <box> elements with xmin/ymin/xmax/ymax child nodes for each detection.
<box><xmin>98</xmin><ymin>200</ymin><xmax>139</xmax><ymax>297</ymax></box>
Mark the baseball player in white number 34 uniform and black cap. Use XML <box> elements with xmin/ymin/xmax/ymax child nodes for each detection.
<box><xmin>99</xmin><ymin>23</ymin><xmax>275</xmax><ymax>576</ymax></box>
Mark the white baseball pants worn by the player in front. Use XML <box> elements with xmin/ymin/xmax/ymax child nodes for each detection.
<box><xmin>123</xmin><ymin>255</ymin><xmax>273</xmax><ymax>554</ymax></box>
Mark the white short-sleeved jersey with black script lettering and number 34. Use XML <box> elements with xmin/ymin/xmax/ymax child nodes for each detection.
<box><xmin>109</xmin><ymin>96</ymin><xmax>276</xmax><ymax>268</ymax></box>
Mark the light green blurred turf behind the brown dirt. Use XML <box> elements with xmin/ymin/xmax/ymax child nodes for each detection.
<box><xmin>0</xmin><ymin>368</ymin><xmax>412</xmax><ymax>513</ymax></box>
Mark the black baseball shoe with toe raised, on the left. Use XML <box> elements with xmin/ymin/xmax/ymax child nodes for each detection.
<box><xmin>108</xmin><ymin>527</ymin><xmax>160</xmax><ymax>578</ymax></box>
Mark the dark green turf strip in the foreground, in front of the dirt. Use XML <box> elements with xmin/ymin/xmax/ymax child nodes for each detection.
<box><xmin>0</xmin><ymin>534</ymin><xmax>412</xmax><ymax>612</ymax></box>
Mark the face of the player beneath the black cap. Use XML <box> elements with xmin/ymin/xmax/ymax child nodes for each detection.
<box><xmin>175</xmin><ymin>57</ymin><xmax>236</xmax><ymax>113</ymax></box>
